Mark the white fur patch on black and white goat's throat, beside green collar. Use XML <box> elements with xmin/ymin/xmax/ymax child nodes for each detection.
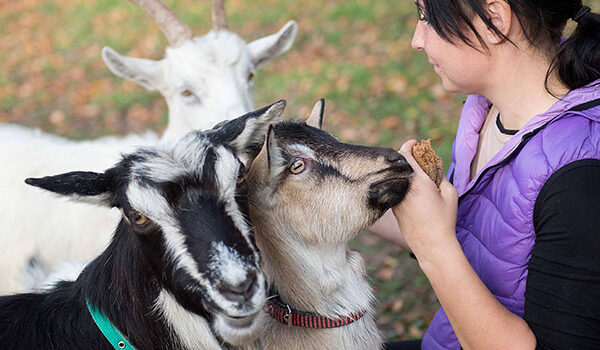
<box><xmin>153</xmin><ymin>290</ymin><xmax>221</xmax><ymax>350</ymax></box>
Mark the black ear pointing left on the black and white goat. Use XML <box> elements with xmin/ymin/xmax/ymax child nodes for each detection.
<box><xmin>25</xmin><ymin>171</ymin><xmax>114</xmax><ymax>207</ymax></box>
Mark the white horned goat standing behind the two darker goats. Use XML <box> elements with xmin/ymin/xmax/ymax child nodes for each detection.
<box><xmin>0</xmin><ymin>0</ymin><xmax>297</xmax><ymax>294</ymax></box>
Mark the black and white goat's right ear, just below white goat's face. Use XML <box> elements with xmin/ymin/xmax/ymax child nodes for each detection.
<box><xmin>210</xmin><ymin>100</ymin><xmax>286</xmax><ymax>158</ymax></box>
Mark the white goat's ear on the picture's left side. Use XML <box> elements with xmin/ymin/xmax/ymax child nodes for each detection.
<box><xmin>102</xmin><ymin>46</ymin><xmax>163</xmax><ymax>91</ymax></box>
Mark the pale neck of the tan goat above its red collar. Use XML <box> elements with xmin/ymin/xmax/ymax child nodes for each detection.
<box><xmin>256</xmin><ymin>225</ymin><xmax>372</xmax><ymax>317</ymax></box>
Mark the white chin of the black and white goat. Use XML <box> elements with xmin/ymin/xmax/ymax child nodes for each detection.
<box><xmin>214</xmin><ymin>311</ymin><xmax>265</xmax><ymax>346</ymax></box>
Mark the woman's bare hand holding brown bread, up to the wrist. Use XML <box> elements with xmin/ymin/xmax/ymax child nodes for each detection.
<box><xmin>392</xmin><ymin>140</ymin><xmax>458</xmax><ymax>262</ymax></box>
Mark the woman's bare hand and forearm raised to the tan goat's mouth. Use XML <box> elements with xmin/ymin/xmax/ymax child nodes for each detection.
<box><xmin>392</xmin><ymin>140</ymin><xmax>535</xmax><ymax>349</ymax></box>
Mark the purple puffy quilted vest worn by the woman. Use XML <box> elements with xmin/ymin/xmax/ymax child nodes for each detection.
<box><xmin>422</xmin><ymin>80</ymin><xmax>600</xmax><ymax>350</ymax></box>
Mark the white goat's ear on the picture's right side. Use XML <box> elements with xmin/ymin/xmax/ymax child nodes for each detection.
<box><xmin>248</xmin><ymin>21</ymin><xmax>298</xmax><ymax>67</ymax></box>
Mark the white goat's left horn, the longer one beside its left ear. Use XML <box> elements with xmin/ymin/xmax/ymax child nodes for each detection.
<box><xmin>130</xmin><ymin>0</ymin><xmax>194</xmax><ymax>47</ymax></box>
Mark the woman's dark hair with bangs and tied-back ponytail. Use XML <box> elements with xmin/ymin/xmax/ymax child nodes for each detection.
<box><xmin>419</xmin><ymin>0</ymin><xmax>600</xmax><ymax>90</ymax></box>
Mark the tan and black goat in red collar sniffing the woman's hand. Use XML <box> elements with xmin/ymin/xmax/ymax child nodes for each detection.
<box><xmin>248</xmin><ymin>100</ymin><xmax>412</xmax><ymax>350</ymax></box>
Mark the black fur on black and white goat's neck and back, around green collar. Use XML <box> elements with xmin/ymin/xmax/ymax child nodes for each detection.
<box><xmin>0</xmin><ymin>222</ymin><xmax>181</xmax><ymax>350</ymax></box>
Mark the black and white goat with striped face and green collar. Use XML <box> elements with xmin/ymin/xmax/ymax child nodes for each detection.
<box><xmin>0</xmin><ymin>101</ymin><xmax>285</xmax><ymax>349</ymax></box>
